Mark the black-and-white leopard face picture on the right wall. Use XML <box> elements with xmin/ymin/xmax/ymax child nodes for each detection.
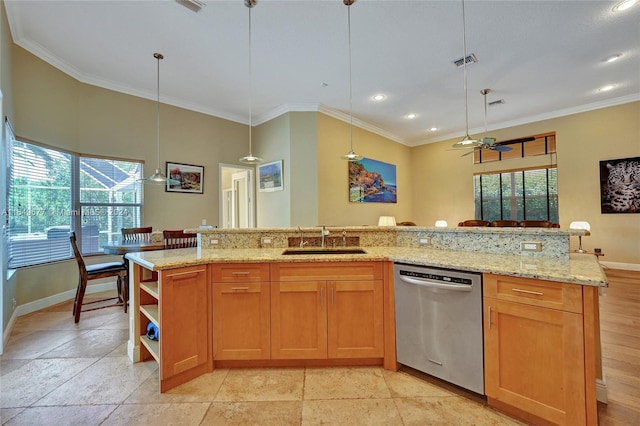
<box><xmin>600</xmin><ymin>157</ymin><xmax>640</xmax><ymax>213</ymax></box>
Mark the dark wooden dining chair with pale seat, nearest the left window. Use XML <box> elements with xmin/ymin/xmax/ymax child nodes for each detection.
<box><xmin>69</xmin><ymin>232</ymin><xmax>129</xmax><ymax>323</ymax></box>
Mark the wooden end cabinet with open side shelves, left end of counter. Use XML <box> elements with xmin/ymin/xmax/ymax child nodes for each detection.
<box><xmin>131</xmin><ymin>264</ymin><xmax>213</xmax><ymax>392</ymax></box>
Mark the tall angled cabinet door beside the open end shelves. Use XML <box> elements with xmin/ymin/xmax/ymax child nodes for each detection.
<box><xmin>159</xmin><ymin>265</ymin><xmax>213</xmax><ymax>382</ymax></box>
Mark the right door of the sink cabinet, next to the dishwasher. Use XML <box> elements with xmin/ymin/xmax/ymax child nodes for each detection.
<box><xmin>327</xmin><ymin>281</ymin><xmax>384</xmax><ymax>358</ymax></box>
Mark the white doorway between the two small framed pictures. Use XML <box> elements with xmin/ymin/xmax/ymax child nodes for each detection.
<box><xmin>219</xmin><ymin>164</ymin><xmax>255</xmax><ymax>228</ymax></box>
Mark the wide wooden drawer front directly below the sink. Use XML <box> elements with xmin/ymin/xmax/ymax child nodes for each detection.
<box><xmin>271</xmin><ymin>262</ymin><xmax>382</xmax><ymax>281</ymax></box>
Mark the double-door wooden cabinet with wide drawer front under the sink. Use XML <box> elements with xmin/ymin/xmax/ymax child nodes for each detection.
<box><xmin>271</xmin><ymin>262</ymin><xmax>384</xmax><ymax>359</ymax></box>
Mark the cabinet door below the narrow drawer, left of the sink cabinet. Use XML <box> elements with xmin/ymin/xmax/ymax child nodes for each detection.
<box><xmin>213</xmin><ymin>282</ymin><xmax>271</xmax><ymax>360</ymax></box>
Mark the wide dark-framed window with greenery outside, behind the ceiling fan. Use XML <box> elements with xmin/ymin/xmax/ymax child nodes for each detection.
<box><xmin>473</xmin><ymin>167</ymin><xmax>558</xmax><ymax>223</ymax></box>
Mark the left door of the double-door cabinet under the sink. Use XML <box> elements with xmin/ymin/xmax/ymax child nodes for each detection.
<box><xmin>271</xmin><ymin>281</ymin><xmax>327</xmax><ymax>359</ymax></box>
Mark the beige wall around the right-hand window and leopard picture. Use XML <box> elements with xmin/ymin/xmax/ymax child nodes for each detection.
<box><xmin>411</xmin><ymin>102</ymin><xmax>640</xmax><ymax>266</ymax></box>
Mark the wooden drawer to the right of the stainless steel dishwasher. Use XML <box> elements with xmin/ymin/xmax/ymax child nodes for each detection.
<box><xmin>482</xmin><ymin>274</ymin><xmax>582</xmax><ymax>313</ymax></box>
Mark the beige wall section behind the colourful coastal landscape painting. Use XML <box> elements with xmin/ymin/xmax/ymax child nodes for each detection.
<box><xmin>318</xmin><ymin>114</ymin><xmax>415</xmax><ymax>226</ymax></box>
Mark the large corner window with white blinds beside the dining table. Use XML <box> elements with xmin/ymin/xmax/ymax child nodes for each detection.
<box><xmin>7</xmin><ymin>139</ymin><xmax>142</xmax><ymax>268</ymax></box>
